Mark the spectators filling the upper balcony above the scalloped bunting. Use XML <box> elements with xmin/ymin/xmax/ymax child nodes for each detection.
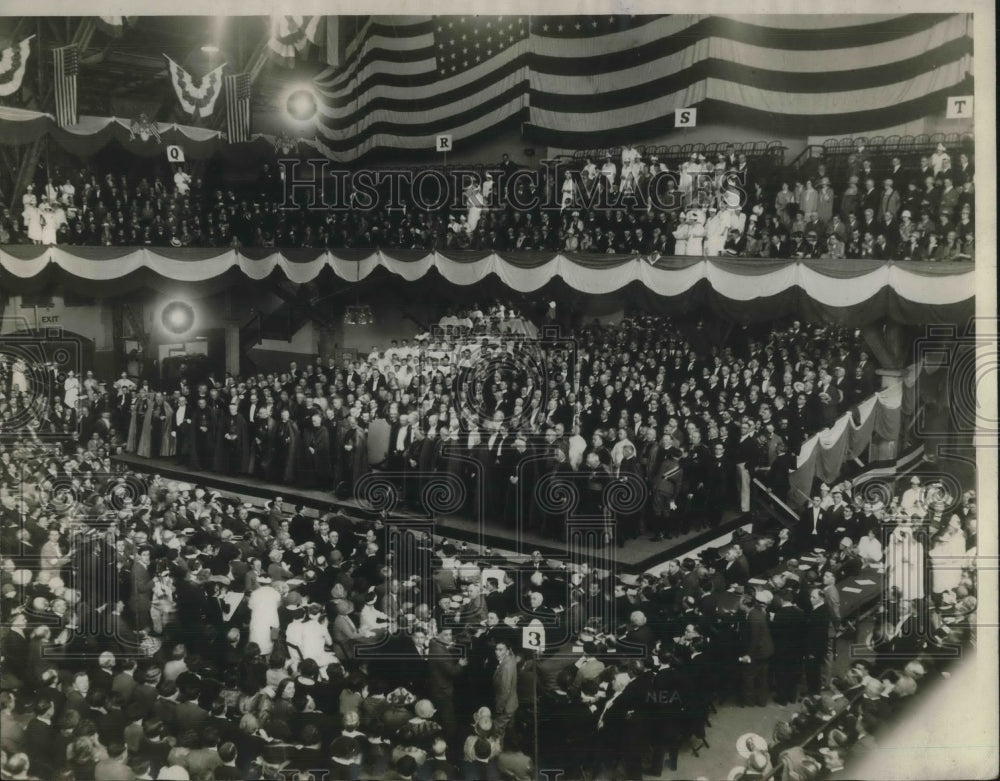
<box><xmin>0</xmin><ymin>141</ymin><xmax>975</xmax><ymax>261</ymax></box>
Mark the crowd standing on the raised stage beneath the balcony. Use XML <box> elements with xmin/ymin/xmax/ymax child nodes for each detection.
<box><xmin>0</xmin><ymin>302</ymin><xmax>878</xmax><ymax>545</ymax></box>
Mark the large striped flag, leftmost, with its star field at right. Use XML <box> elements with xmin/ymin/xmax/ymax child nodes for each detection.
<box><xmin>314</xmin><ymin>16</ymin><xmax>530</xmax><ymax>160</ymax></box>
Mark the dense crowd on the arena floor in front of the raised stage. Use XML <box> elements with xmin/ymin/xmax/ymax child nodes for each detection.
<box><xmin>0</xmin><ymin>374</ymin><xmax>976</xmax><ymax>781</ymax></box>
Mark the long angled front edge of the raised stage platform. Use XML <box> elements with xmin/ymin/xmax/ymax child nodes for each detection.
<box><xmin>113</xmin><ymin>455</ymin><xmax>748</xmax><ymax>574</ymax></box>
